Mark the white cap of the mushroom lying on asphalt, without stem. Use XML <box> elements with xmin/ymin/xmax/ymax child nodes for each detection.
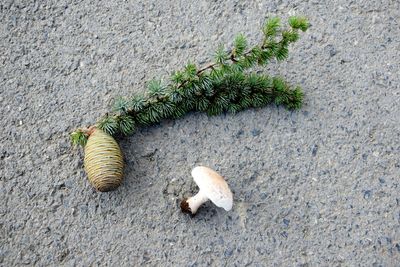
<box><xmin>192</xmin><ymin>166</ymin><xmax>233</xmax><ymax>211</ymax></box>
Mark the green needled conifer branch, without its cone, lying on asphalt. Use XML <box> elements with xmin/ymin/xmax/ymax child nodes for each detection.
<box><xmin>71</xmin><ymin>17</ymin><xmax>309</xmax><ymax>146</ymax></box>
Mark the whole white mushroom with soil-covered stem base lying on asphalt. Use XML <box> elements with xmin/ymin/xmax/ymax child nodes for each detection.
<box><xmin>181</xmin><ymin>166</ymin><xmax>233</xmax><ymax>215</ymax></box>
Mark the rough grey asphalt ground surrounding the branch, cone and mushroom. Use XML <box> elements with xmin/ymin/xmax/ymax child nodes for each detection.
<box><xmin>0</xmin><ymin>0</ymin><xmax>400</xmax><ymax>266</ymax></box>
